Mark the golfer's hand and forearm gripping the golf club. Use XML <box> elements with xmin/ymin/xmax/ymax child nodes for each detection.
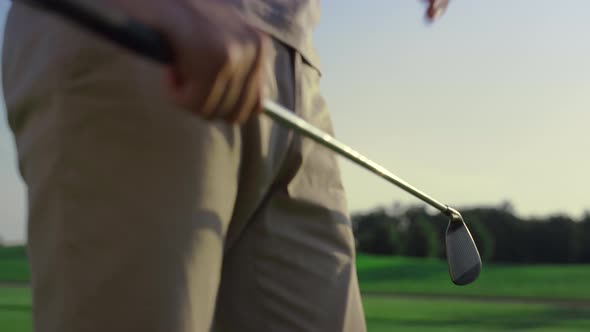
<box><xmin>104</xmin><ymin>0</ymin><xmax>268</xmax><ymax>123</ymax></box>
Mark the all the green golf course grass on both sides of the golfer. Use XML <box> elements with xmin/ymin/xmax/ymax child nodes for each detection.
<box><xmin>0</xmin><ymin>248</ymin><xmax>590</xmax><ymax>332</ymax></box>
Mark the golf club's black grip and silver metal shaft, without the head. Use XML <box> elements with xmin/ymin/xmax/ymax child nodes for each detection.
<box><xmin>13</xmin><ymin>0</ymin><xmax>453</xmax><ymax>215</ymax></box>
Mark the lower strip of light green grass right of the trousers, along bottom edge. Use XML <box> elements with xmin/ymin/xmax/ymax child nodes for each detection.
<box><xmin>364</xmin><ymin>296</ymin><xmax>590</xmax><ymax>332</ymax></box>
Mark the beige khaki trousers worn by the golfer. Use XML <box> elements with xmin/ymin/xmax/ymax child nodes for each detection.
<box><xmin>3</xmin><ymin>5</ymin><xmax>365</xmax><ymax>332</ymax></box>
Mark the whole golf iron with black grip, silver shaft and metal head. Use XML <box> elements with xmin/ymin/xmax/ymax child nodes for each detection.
<box><xmin>13</xmin><ymin>0</ymin><xmax>482</xmax><ymax>285</ymax></box>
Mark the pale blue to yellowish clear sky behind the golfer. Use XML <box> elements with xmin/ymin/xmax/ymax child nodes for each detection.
<box><xmin>0</xmin><ymin>0</ymin><xmax>590</xmax><ymax>242</ymax></box>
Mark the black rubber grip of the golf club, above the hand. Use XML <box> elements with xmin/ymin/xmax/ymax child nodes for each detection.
<box><xmin>13</xmin><ymin>0</ymin><xmax>174</xmax><ymax>64</ymax></box>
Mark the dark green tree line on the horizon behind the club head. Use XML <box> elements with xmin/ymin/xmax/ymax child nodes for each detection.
<box><xmin>352</xmin><ymin>203</ymin><xmax>590</xmax><ymax>264</ymax></box>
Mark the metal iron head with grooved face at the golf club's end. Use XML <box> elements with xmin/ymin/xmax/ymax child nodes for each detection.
<box><xmin>445</xmin><ymin>209</ymin><xmax>481</xmax><ymax>286</ymax></box>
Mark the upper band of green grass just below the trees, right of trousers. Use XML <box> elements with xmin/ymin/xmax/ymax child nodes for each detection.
<box><xmin>357</xmin><ymin>256</ymin><xmax>590</xmax><ymax>301</ymax></box>
